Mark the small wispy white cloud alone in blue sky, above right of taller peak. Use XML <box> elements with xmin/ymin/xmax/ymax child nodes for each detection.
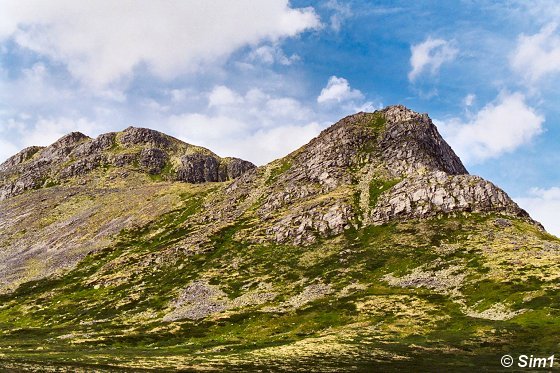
<box><xmin>408</xmin><ymin>37</ymin><xmax>459</xmax><ymax>82</ymax></box>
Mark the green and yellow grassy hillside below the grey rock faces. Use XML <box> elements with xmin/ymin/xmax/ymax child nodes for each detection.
<box><xmin>0</xmin><ymin>209</ymin><xmax>560</xmax><ymax>371</ymax></box>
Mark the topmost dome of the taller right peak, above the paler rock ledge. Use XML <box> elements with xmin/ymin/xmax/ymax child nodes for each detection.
<box><xmin>276</xmin><ymin>105</ymin><xmax>468</xmax><ymax>193</ymax></box>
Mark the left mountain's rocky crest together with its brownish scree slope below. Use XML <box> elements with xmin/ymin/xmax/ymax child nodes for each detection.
<box><xmin>0</xmin><ymin>127</ymin><xmax>255</xmax><ymax>291</ymax></box>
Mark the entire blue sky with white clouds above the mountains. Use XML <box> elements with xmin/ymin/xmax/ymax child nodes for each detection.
<box><xmin>0</xmin><ymin>0</ymin><xmax>560</xmax><ymax>236</ymax></box>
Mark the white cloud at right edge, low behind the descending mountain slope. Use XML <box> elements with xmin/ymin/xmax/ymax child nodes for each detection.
<box><xmin>514</xmin><ymin>187</ymin><xmax>560</xmax><ymax>237</ymax></box>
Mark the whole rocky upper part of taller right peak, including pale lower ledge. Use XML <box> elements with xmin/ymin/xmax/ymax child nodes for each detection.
<box><xmin>220</xmin><ymin>105</ymin><xmax>540</xmax><ymax>244</ymax></box>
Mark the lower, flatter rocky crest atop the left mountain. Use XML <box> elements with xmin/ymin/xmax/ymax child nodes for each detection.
<box><xmin>0</xmin><ymin>127</ymin><xmax>255</xmax><ymax>200</ymax></box>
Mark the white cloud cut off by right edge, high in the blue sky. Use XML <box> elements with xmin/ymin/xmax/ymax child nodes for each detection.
<box><xmin>510</xmin><ymin>23</ymin><xmax>560</xmax><ymax>82</ymax></box>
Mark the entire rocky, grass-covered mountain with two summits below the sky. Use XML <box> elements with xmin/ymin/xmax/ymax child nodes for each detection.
<box><xmin>0</xmin><ymin>105</ymin><xmax>560</xmax><ymax>371</ymax></box>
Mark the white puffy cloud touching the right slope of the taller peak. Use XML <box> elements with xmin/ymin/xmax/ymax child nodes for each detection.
<box><xmin>436</xmin><ymin>92</ymin><xmax>544</xmax><ymax>163</ymax></box>
